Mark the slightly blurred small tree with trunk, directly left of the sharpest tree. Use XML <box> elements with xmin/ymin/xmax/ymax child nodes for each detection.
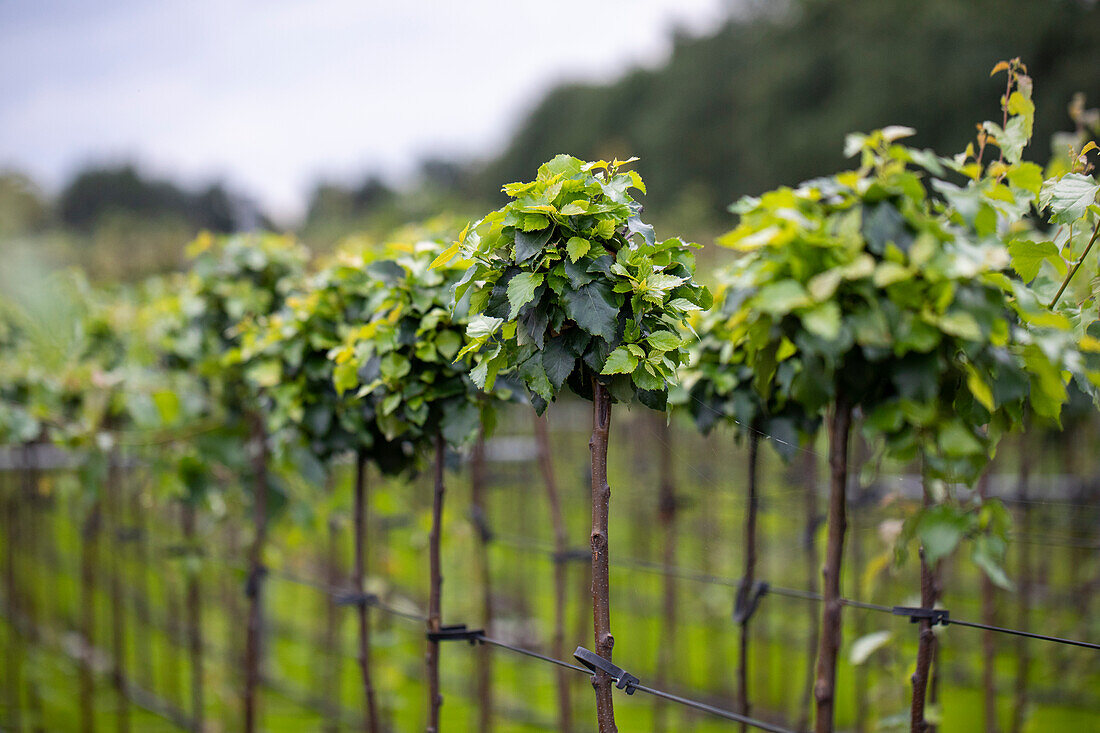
<box><xmin>330</xmin><ymin>236</ymin><xmax>508</xmax><ymax>733</ymax></box>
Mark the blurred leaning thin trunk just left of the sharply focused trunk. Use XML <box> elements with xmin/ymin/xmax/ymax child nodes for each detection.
<box><xmin>535</xmin><ymin>415</ymin><xmax>583</xmax><ymax>733</ymax></box>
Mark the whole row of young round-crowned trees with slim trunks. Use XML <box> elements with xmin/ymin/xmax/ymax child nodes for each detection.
<box><xmin>0</xmin><ymin>61</ymin><xmax>1100</xmax><ymax>733</ymax></box>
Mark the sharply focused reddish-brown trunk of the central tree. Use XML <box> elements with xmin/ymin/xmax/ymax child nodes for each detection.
<box><xmin>589</xmin><ymin>378</ymin><xmax>618</xmax><ymax>733</ymax></box>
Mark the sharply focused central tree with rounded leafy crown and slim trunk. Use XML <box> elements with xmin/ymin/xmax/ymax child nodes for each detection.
<box><xmin>438</xmin><ymin>150</ymin><xmax>711</xmax><ymax>733</ymax></box>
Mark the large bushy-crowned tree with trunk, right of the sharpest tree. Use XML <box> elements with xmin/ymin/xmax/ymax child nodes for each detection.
<box><xmin>721</xmin><ymin>122</ymin><xmax>1073</xmax><ymax>733</ymax></box>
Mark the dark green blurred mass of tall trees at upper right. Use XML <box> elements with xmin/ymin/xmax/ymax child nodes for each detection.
<box><xmin>481</xmin><ymin>0</ymin><xmax>1100</xmax><ymax>226</ymax></box>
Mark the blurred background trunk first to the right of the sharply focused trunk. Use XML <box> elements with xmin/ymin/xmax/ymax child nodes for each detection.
<box><xmin>646</xmin><ymin>413</ymin><xmax>678</xmax><ymax>733</ymax></box>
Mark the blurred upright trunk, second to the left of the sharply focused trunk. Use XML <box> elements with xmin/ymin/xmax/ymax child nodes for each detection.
<box><xmin>470</xmin><ymin>429</ymin><xmax>493</xmax><ymax>733</ymax></box>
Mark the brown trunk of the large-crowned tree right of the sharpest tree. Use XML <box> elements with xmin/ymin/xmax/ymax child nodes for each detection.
<box><xmin>814</xmin><ymin>397</ymin><xmax>851</xmax><ymax>733</ymax></box>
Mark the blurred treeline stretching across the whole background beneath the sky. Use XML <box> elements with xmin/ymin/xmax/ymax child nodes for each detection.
<box><xmin>0</xmin><ymin>0</ymin><xmax>1100</xmax><ymax>277</ymax></box>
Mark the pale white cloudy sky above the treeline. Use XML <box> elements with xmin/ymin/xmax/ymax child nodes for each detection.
<box><xmin>0</xmin><ymin>0</ymin><xmax>732</xmax><ymax>218</ymax></box>
